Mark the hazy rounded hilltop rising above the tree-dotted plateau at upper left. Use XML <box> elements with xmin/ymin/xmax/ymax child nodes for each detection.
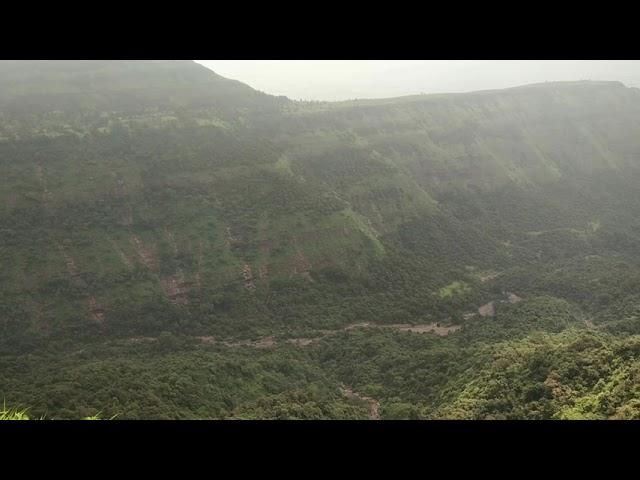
<box><xmin>0</xmin><ymin>60</ymin><xmax>288</xmax><ymax>113</ymax></box>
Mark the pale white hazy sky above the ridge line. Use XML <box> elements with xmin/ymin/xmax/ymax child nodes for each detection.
<box><xmin>196</xmin><ymin>60</ymin><xmax>640</xmax><ymax>100</ymax></box>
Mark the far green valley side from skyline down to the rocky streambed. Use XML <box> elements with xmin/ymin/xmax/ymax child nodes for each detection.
<box><xmin>0</xmin><ymin>62</ymin><xmax>640</xmax><ymax>346</ymax></box>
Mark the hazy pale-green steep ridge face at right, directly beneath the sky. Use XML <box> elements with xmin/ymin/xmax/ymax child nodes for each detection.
<box><xmin>282</xmin><ymin>82</ymin><xmax>640</xmax><ymax>193</ymax></box>
